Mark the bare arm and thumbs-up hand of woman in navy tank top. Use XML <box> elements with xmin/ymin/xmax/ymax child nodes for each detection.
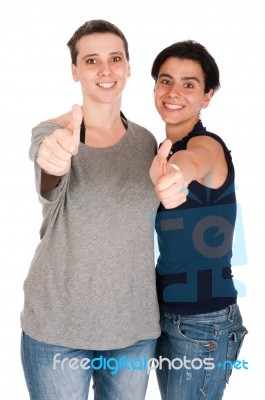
<box><xmin>150</xmin><ymin>136</ymin><xmax>227</xmax><ymax>208</ymax></box>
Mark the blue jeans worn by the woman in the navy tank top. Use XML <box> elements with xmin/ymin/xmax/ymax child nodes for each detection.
<box><xmin>156</xmin><ymin>304</ymin><xmax>247</xmax><ymax>400</ymax></box>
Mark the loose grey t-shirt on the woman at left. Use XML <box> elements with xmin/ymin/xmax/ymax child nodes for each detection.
<box><xmin>21</xmin><ymin>121</ymin><xmax>160</xmax><ymax>350</ymax></box>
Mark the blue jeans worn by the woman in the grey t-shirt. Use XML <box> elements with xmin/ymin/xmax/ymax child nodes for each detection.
<box><xmin>21</xmin><ymin>332</ymin><xmax>157</xmax><ymax>400</ymax></box>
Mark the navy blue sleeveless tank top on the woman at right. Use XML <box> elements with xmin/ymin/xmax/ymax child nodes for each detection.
<box><xmin>155</xmin><ymin>121</ymin><xmax>237</xmax><ymax>315</ymax></box>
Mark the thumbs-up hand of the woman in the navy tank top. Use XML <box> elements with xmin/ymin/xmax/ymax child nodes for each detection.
<box><xmin>150</xmin><ymin>139</ymin><xmax>188</xmax><ymax>209</ymax></box>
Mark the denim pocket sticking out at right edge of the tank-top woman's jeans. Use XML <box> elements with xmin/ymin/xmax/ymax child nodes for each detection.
<box><xmin>226</xmin><ymin>324</ymin><xmax>248</xmax><ymax>383</ymax></box>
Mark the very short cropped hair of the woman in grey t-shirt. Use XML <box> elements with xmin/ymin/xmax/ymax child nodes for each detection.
<box><xmin>67</xmin><ymin>19</ymin><xmax>129</xmax><ymax>65</ymax></box>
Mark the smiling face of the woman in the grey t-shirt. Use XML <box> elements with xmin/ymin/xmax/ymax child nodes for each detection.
<box><xmin>72</xmin><ymin>33</ymin><xmax>130</xmax><ymax>103</ymax></box>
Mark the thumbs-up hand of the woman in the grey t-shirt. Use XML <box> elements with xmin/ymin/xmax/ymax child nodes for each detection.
<box><xmin>37</xmin><ymin>105</ymin><xmax>83</xmax><ymax>176</ymax></box>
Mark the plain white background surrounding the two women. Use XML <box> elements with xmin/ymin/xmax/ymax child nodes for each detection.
<box><xmin>0</xmin><ymin>0</ymin><xmax>265</xmax><ymax>400</ymax></box>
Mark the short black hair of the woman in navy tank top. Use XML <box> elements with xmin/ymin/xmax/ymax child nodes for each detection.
<box><xmin>151</xmin><ymin>40</ymin><xmax>220</xmax><ymax>93</ymax></box>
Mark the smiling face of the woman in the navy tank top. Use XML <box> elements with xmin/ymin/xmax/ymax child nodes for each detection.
<box><xmin>154</xmin><ymin>57</ymin><xmax>213</xmax><ymax>136</ymax></box>
